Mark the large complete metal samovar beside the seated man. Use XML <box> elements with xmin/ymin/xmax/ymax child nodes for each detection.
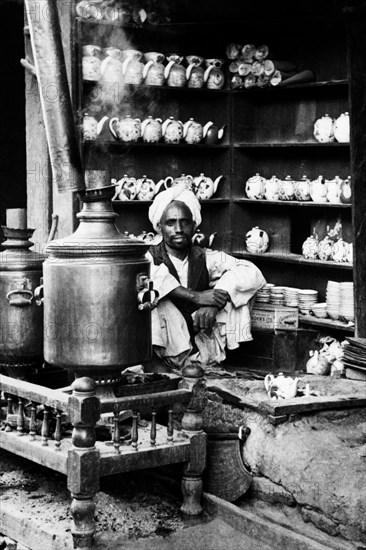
<box><xmin>37</xmin><ymin>171</ymin><xmax>156</xmax><ymax>396</ymax></box>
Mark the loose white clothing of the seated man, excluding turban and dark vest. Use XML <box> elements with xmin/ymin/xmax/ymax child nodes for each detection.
<box><xmin>147</xmin><ymin>249</ymin><xmax>266</xmax><ymax>368</ymax></box>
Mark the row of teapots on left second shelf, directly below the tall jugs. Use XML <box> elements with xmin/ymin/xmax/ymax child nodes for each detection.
<box><xmin>83</xmin><ymin>114</ymin><xmax>225</xmax><ymax>145</ymax></box>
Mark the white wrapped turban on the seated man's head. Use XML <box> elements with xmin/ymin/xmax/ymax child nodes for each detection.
<box><xmin>149</xmin><ymin>183</ymin><xmax>202</xmax><ymax>231</ymax></box>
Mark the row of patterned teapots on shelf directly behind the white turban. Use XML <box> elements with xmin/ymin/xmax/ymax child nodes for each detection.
<box><xmin>112</xmin><ymin>173</ymin><xmax>223</xmax><ymax>201</ymax></box>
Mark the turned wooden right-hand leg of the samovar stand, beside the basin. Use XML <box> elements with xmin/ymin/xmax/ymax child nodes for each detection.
<box><xmin>179</xmin><ymin>364</ymin><xmax>207</xmax><ymax>516</ymax></box>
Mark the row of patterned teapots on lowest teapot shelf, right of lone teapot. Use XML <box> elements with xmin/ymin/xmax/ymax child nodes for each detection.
<box><xmin>302</xmin><ymin>233</ymin><xmax>353</xmax><ymax>264</ymax></box>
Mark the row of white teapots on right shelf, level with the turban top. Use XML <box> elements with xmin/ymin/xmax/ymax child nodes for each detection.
<box><xmin>245</xmin><ymin>173</ymin><xmax>352</xmax><ymax>204</ymax></box>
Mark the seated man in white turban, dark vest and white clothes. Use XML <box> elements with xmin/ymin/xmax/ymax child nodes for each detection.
<box><xmin>148</xmin><ymin>184</ymin><xmax>266</xmax><ymax>369</ymax></box>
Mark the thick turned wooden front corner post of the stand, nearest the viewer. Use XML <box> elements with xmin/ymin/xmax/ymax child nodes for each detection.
<box><xmin>67</xmin><ymin>377</ymin><xmax>100</xmax><ymax>549</ymax></box>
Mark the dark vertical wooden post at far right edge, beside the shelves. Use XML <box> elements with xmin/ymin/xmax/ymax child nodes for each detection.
<box><xmin>348</xmin><ymin>8</ymin><xmax>366</xmax><ymax>338</ymax></box>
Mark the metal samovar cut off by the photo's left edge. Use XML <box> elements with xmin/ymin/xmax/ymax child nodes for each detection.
<box><xmin>0</xmin><ymin>208</ymin><xmax>44</xmax><ymax>379</ymax></box>
